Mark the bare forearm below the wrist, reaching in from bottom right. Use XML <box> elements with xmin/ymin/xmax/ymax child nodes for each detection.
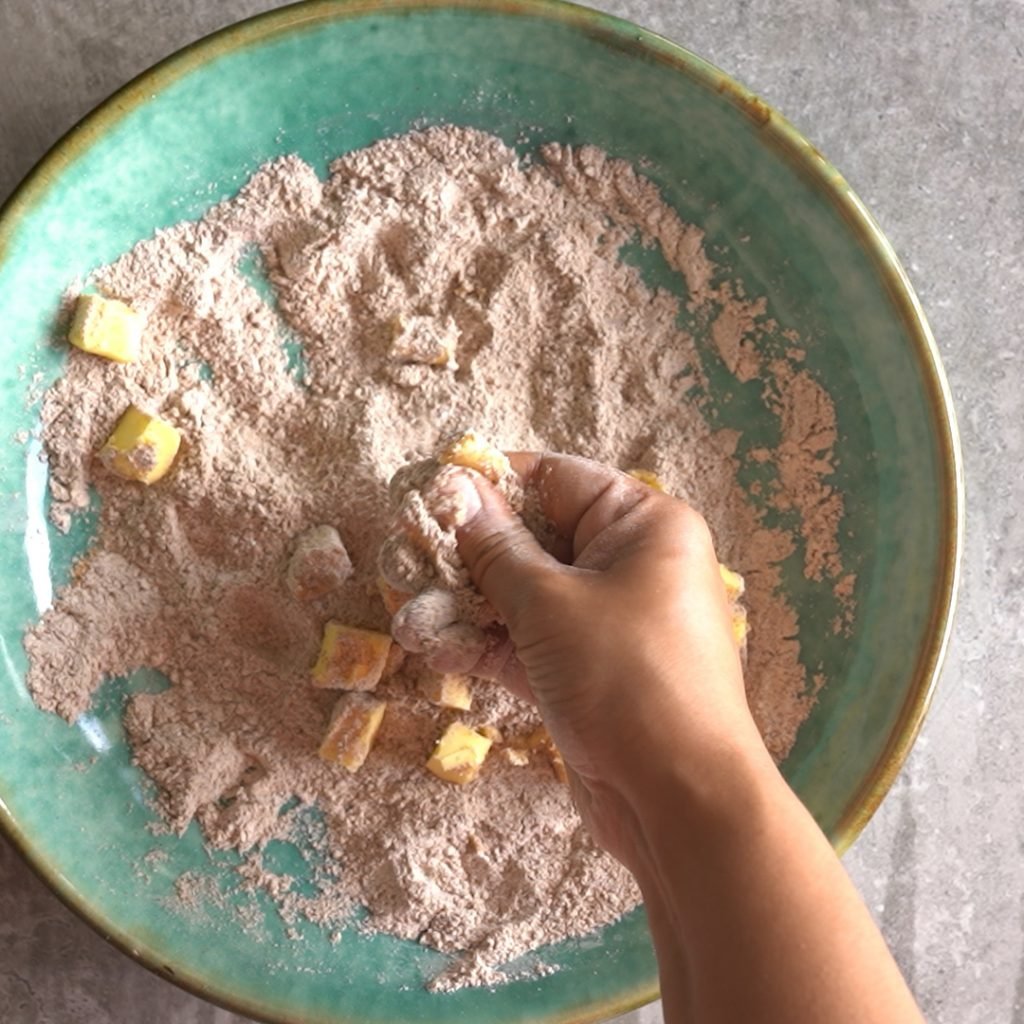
<box><xmin>635</xmin><ymin>737</ymin><xmax>922</xmax><ymax>1024</ymax></box>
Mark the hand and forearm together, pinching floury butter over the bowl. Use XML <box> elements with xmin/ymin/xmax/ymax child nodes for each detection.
<box><xmin>415</xmin><ymin>455</ymin><xmax>923</xmax><ymax>1024</ymax></box>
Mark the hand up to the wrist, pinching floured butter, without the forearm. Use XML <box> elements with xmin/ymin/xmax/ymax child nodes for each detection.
<box><xmin>445</xmin><ymin>454</ymin><xmax>764</xmax><ymax>866</ymax></box>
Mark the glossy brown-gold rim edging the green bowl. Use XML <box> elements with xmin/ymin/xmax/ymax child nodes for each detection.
<box><xmin>0</xmin><ymin>0</ymin><xmax>965</xmax><ymax>1024</ymax></box>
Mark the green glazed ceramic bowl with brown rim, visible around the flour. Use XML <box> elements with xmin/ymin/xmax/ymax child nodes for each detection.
<box><xmin>0</xmin><ymin>0</ymin><xmax>963</xmax><ymax>1024</ymax></box>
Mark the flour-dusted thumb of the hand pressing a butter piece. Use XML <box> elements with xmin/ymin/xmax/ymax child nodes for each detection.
<box><xmin>449</xmin><ymin>471</ymin><xmax>562</xmax><ymax>631</ymax></box>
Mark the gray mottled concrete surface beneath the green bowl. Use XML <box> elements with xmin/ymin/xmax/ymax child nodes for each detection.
<box><xmin>0</xmin><ymin>0</ymin><xmax>1024</xmax><ymax>1024</ymax></box>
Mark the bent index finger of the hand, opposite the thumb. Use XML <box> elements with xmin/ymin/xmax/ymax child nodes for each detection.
<box><xmin>508</xmin><ymin>452</ymin><xmax>656</xmax><ymax>559</ymax></box>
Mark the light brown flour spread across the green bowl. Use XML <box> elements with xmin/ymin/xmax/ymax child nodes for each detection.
<box><xmin>26</xmin><ymin>128</ymin><xmax>842</xmax><ymax>988</ymax></box>
